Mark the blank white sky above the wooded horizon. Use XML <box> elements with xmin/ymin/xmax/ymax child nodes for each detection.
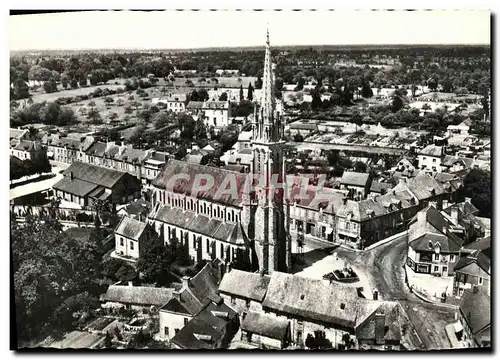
<box><xmin>9</xmin><ymin>10</ymin><xmax>490</xmax><ymax>51</ymax></box>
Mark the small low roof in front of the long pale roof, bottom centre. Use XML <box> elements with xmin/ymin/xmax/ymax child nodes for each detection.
<box><xmin>240</xmin><ymin>311</ymin><xmax>289</xmax><ymax>341</ymax></box>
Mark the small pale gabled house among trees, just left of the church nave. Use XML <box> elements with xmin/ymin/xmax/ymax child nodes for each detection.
<box><xmin>111</xmin><ymin>216</ymin><xmax>152</xmax><ymax>262</ymax></box>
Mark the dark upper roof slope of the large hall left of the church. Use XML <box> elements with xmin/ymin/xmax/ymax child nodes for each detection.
<box><xmin>63</xmin><ymin>161</ymin><xmax>126</xmax><ymax>189</ymax></box>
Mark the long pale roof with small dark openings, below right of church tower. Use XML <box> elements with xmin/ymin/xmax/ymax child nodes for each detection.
<box><xmin>262</xmin><ymin>271</ymin><xmax>358</xmax><ymax>329</ymax></box>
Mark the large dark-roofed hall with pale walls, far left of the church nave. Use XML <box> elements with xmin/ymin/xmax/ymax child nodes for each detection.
<box><xmin>53</xmin><ymin>161</ymin><xmax>141</xmax><ymax>206</ymax></box>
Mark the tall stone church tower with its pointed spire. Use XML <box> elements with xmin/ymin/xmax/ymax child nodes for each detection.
<box><xmin>243</xmin><ymin>30</ymin><xmax>291</xmax><ymax>274</ymax></box>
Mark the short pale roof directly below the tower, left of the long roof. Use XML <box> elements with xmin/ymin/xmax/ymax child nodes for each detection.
<box><xmin>219</xmin><ymin>269</ymin><xmax>271</xmax><ymax>302</ymax></box>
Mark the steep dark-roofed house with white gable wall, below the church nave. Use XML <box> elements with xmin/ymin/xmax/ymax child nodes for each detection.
<box><xmin>158</xmin><ymin>261</ymin><xmax>223</xmax><ymax>341</ymax></box>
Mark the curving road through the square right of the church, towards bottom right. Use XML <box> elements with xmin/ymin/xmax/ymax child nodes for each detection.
<box><xmin>296</xmin><ymin>232</ymin><xmax>455</xmax><ymax>349</ymax></box>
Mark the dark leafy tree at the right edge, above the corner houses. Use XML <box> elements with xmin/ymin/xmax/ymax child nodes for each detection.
<box><xmin>461</xmin><ymin>169</ymin><xmax>492</xmax><ymax>218</ymax></box>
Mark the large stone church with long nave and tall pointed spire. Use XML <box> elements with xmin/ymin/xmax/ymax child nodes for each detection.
<box><xmin>148</xmin><ymin>32</ymin><xmax>292</xmax><ymax>274</ymax></box>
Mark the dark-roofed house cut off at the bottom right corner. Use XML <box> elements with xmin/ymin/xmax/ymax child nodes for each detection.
<box><xmin>454</xmin><ymin>287</ymin><xmax>491</xmax><ymax>348</ymax></box>
